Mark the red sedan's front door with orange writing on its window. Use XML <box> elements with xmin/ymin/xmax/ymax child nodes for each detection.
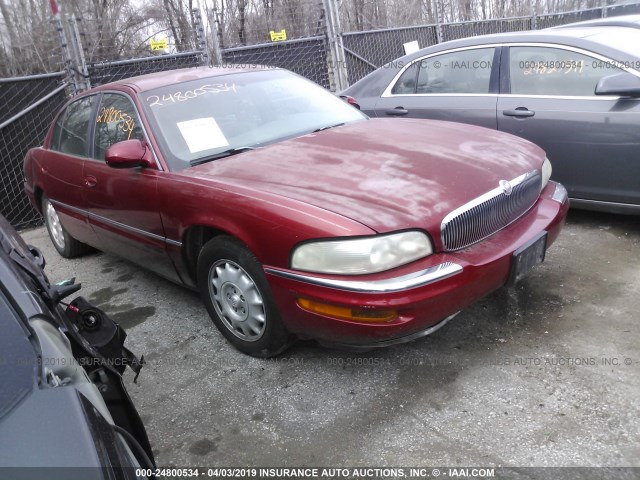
<box><xmin>84</xmin><ymin>92</ymin><xmax>177</xmax><ymax>280</ymax></box>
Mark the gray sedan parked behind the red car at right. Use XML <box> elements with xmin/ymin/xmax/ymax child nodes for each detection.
<box><xmin>341</xmin><ymin>22</ymin><xmax>640</xmax><ymax>214</ymax></box>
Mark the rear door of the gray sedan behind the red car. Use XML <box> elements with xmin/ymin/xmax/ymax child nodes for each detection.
<box><xmin>375</xmin><ymin>46</ymin><xmax>500</xmax><ymax>129</ymax></box>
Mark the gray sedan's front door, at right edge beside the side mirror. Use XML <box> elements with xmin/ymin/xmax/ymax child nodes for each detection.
<box><xmin>498</xmin><ymin>44</ymin><xmax>640</xmax><ymax>208</ymax></box>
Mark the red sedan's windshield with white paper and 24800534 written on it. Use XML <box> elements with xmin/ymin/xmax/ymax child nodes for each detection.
<box><xmin>140</xmin><ymin>70</ymin><xmax>367</xmax><ymax>170</ymax></box>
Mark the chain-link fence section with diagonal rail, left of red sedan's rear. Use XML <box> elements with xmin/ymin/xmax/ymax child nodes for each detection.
<box><xmin>0</xmin><ymin>73</ymin><xmax>67</xmax><ymax>228</ymax></box>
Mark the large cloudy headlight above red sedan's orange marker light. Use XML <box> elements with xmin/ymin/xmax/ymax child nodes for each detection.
<box><xmin>291</xmin><ymin>231</ymin><xmax>433</xmax><ymax>275</ymax></box>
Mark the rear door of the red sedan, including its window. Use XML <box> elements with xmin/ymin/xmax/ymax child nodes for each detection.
<box><xmin>38</xmin><ymin>95</ymin><xmax>96</xmax><ymax>245</ymax></box>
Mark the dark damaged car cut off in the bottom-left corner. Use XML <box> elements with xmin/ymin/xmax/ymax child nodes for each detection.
<box><xmin>0</xmin><ymin>215</ymin><xmax>155</xmax><ymax>480</ymax></box>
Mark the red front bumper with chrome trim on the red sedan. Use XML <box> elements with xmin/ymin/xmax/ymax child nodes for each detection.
<box><xmin>265</xmin><ymin>182</ymin><xmax>569</xmax><ymax>347</ymax></box>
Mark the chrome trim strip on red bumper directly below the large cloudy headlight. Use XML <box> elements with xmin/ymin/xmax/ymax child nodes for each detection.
<box><xmin>265</xmin><ymin>262</ymin><xmax>462</xmax><ymax>293</ymax></box>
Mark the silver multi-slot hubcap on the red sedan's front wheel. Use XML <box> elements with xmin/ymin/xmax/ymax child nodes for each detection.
<box><xmin>209</xmin><ymin>260</ymin><xmax>267</xmax><ymax>342</ymax></box>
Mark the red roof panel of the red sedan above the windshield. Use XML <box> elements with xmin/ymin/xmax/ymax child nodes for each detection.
<box><xmin>90</xmin><ymin>65</ymin><xmax>275</xmax><ymax>92</ymax></box>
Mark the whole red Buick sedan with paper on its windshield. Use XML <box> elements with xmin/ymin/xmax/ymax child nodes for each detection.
<box><xmin>24</xmin><ymin>67</ymin><xmax>568</xmax><ymax>357</ymax></box>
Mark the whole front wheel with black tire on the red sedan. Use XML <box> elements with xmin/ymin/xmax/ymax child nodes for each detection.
<box><xmin>197</xmin><ymin>235</ymin><xmax>293</xmax><ymax>358</ymax></box>
